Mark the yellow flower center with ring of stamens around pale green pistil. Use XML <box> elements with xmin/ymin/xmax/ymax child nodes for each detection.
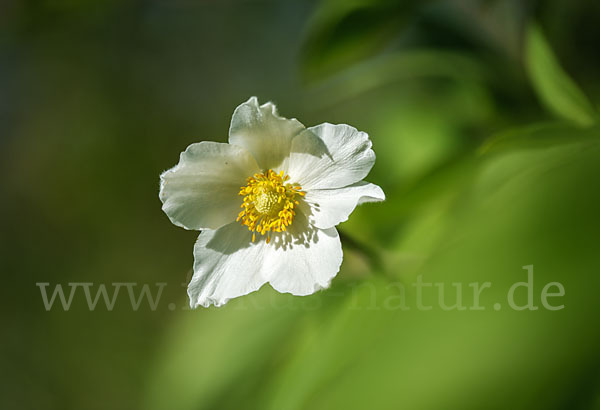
<box><xmin>237</xmin><ymin>169</ymin><xmax>304</xmax><ymax>243</ymax></box>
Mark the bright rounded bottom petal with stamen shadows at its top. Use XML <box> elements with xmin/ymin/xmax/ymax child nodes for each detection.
<box><xmin>265</xmin><ymin>213</ymin><xmax>343</xmax><ymax>296</ymax></box>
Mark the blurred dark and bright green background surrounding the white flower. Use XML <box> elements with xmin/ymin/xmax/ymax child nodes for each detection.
<box><xmin>0</xmin><ymin>0</ymin><xmax>600</xmax><ymax>410</ymax></box>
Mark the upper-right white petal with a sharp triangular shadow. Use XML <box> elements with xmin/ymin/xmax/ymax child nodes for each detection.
<box><xmin>287</xmin><ymin>123</ymin><xmax>375</xmax><ymax>190</ymax></box>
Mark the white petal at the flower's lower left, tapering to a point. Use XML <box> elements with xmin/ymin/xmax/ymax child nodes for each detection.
<box><xmin>188</xmin><ymin>222</ymin><xmax>273</xmax><ymax>308</ymax></box>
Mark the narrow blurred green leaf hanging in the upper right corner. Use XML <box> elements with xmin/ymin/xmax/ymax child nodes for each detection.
<box><xmin>525</xmin><ymin>24</ymin><xmax>597</xmax><ymax>126</ymax></box>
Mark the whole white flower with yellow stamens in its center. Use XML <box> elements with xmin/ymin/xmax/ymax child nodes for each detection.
<box><xmin>160</xmin><ymin>97</ymin><xmax>385</xmax><ymax>307</ymax></box>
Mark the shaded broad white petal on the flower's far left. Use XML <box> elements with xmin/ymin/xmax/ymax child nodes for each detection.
<box><xmin>159</xmin><ymin>141</ymin><xmax>259</xmax><ymax>230</ymax></box>
